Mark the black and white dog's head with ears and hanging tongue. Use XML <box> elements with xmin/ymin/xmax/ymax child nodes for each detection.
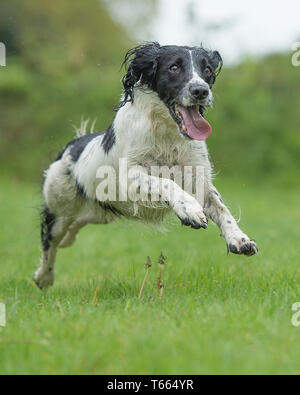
<box><xmin>121</xmin><ymin>43</ymin><xmax>223</xmax><ymax>140</ymax></box>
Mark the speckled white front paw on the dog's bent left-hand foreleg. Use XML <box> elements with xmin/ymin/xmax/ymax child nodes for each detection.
<box><xmin>174</xmin><ymin>199</ymin><xmax>208</xmax><ymax>229</ymax></box>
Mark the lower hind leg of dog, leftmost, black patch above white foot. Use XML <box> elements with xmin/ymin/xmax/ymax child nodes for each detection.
<box><xmin>34</xmin><ymin>208</ymin><xmax>72</xmax><ymax>289</ymax></box>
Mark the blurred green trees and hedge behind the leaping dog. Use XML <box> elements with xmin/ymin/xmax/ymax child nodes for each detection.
<box><xmin>0</xmin><ymin>0</ymin><xmax>300</xmax><ymax>184</ymax></box>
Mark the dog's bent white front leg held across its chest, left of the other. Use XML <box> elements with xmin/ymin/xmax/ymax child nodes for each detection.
<box><xmin>131</xmin><ymin>171</ymin><xmax>207</xmax><ymax>229</ymax></box>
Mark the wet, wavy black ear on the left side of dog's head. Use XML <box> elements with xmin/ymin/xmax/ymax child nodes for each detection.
<box><xmin>120</xmin><ymin>42</ymin><xmax>161</xmax><ymax>107</ymax></box>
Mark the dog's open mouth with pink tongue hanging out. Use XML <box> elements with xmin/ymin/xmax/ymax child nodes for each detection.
<box><xmin>170</xmin><ymin>104</ymin><xmax>212</xmax><ymax>141</ymax></box>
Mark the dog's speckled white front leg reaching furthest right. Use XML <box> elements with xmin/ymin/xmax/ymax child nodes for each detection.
<box><xmin>204</xmin><ymin>185</ymin><xmax>258</xmax><ymax>256</ymax></box>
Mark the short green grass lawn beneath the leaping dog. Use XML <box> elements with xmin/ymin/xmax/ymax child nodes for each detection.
<box><xmin>0</xmin><ymin>177</ymin><xmax>300</xmax><ymax>374</ymax></box>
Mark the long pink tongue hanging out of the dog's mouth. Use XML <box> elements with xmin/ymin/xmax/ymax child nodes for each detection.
<box><xmin>178</xmin><ymin>106</ymin><xmax>212</xmax><ymax>140</ymax></box>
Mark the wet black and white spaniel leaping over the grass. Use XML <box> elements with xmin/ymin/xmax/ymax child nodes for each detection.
<box><xmin>35</xmin><ymin>43</ymin><xmax>258</xmax><ymax>288</ymax></box>
